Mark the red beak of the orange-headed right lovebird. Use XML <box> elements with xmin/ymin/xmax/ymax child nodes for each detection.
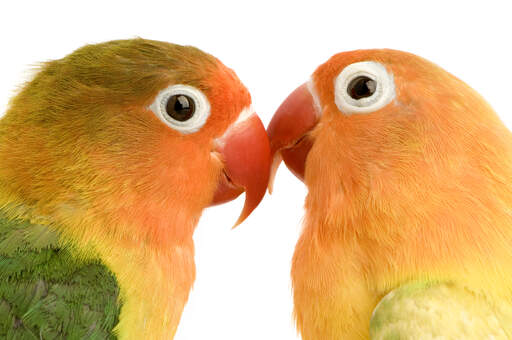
<box><xmin>267</xmin><ymin>83</ymin><xmax>318</xmax><ymax>193</ymax></box>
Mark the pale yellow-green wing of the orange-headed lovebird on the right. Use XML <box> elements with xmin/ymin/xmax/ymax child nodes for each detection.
<box><xmin>370</xmin><ymin>282</ymin><xmax>512</xmax><ymax>340</ymax></box>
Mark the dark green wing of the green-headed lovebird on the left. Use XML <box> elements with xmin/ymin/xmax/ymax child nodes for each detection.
<box><xmin>0</xmin><ymin>215</ymin><xmax>120</xmax><ymax>339</ymax></box>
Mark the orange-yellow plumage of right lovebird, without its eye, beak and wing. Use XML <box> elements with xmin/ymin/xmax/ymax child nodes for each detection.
<box><xmin>284</xmin><ymin>50</ymin><xmax>512</xmax><ymax>340</ymax></box>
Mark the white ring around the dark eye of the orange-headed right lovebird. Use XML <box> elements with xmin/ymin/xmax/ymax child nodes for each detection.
<box><xmin>334</xmin><ymin>61</ymin><xmax>395</xmax><ymax>115</ymax></box>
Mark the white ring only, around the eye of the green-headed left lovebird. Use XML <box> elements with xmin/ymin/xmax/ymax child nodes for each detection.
<box><xmin>149</xmin><ymin>84</ymin><xmax>210</xmax><ymax>134</ymax></box>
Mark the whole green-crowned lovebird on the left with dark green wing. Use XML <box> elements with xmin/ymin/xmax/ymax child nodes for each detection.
<box><xmin>0</xmin><ymin>38</ymin><xmax>271</xmax><ymax>339</ymax></box>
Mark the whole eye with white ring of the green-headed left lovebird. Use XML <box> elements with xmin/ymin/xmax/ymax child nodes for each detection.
<box><xmin>149</xmin><ymin>84</ymin><xmax>210</xmax><ymax>134</ymax></box>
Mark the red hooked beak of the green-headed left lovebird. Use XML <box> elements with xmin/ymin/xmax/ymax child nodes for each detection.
<box><xmin>211</xmin><ymin>109</ymin><xmax>270</xmax><ymax>227</ymax></box>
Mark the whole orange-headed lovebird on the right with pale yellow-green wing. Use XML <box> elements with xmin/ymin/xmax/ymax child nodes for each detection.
<box><xmin>267</xmin><ymin>49</ymin><xmax>512</xmax><ymax>340</ymax></box>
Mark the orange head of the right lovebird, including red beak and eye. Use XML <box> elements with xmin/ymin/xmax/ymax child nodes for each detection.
<box><xmin>267</xmin><ymin>50</ymin><xmax>510</xmax><ymax>216</ymax></box>
